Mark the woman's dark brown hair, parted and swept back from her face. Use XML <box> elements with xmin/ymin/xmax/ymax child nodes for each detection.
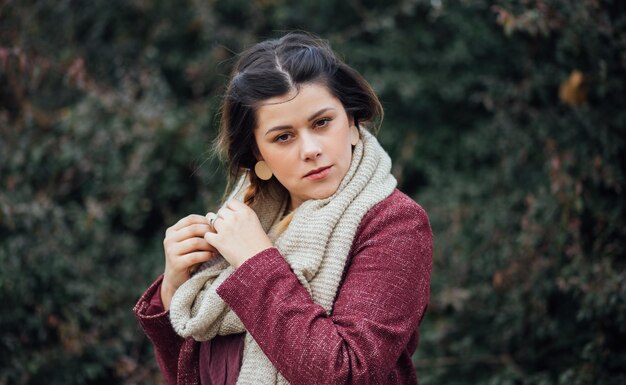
<box><xmin>216</xmin><ymin>32</ymin><xmax>383</xmax><ymax>204</ymax></box>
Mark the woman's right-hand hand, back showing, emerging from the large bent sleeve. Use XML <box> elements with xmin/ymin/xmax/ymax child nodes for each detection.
<box><xmin>204</xmin><ymin>199</ymin><xmax>274</xmax><ymax>268</ymax></box>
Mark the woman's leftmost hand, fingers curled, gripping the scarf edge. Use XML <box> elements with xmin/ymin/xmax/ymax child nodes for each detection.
<box><xmin>161</xmin><ymin>214</ymin><xmax>218</xmax><ymax>310</ymax></box>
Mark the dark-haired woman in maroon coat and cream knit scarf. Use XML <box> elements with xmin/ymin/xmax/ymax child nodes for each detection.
<box><xmin>135</xmin><ymin>33</ymin><xmax>432</xmax><ymax>385</ymax></box>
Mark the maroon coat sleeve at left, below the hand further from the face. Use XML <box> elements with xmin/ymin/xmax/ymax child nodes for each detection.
<box><xmin>133</xmin><ymin>276</ymin><xmax>185</xmax><ymax>385</ymax></box>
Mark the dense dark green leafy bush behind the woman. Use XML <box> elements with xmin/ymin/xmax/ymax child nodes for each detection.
<box><xmin>0</xmin><ymin>0</ymin><xmax>626</xmax><ymax>385</ymax></box>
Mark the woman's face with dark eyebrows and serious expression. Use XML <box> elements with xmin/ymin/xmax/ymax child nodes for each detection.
<box><xmin>254</xmin><ymin>84</ymin><xmax>352</xmax><ymax>209</ymax></box>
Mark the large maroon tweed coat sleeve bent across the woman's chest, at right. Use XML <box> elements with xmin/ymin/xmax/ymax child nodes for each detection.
<box><xmin>217</xmin><ymin>198</ymin><xmax>432</xmax><ymax>385</ymax></box>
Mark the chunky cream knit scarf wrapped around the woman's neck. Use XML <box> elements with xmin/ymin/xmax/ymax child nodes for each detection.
<box><xmin>170</xmin><ymin>130</ymin><xmax>396</xmax><ymax>385</ymax></box>
